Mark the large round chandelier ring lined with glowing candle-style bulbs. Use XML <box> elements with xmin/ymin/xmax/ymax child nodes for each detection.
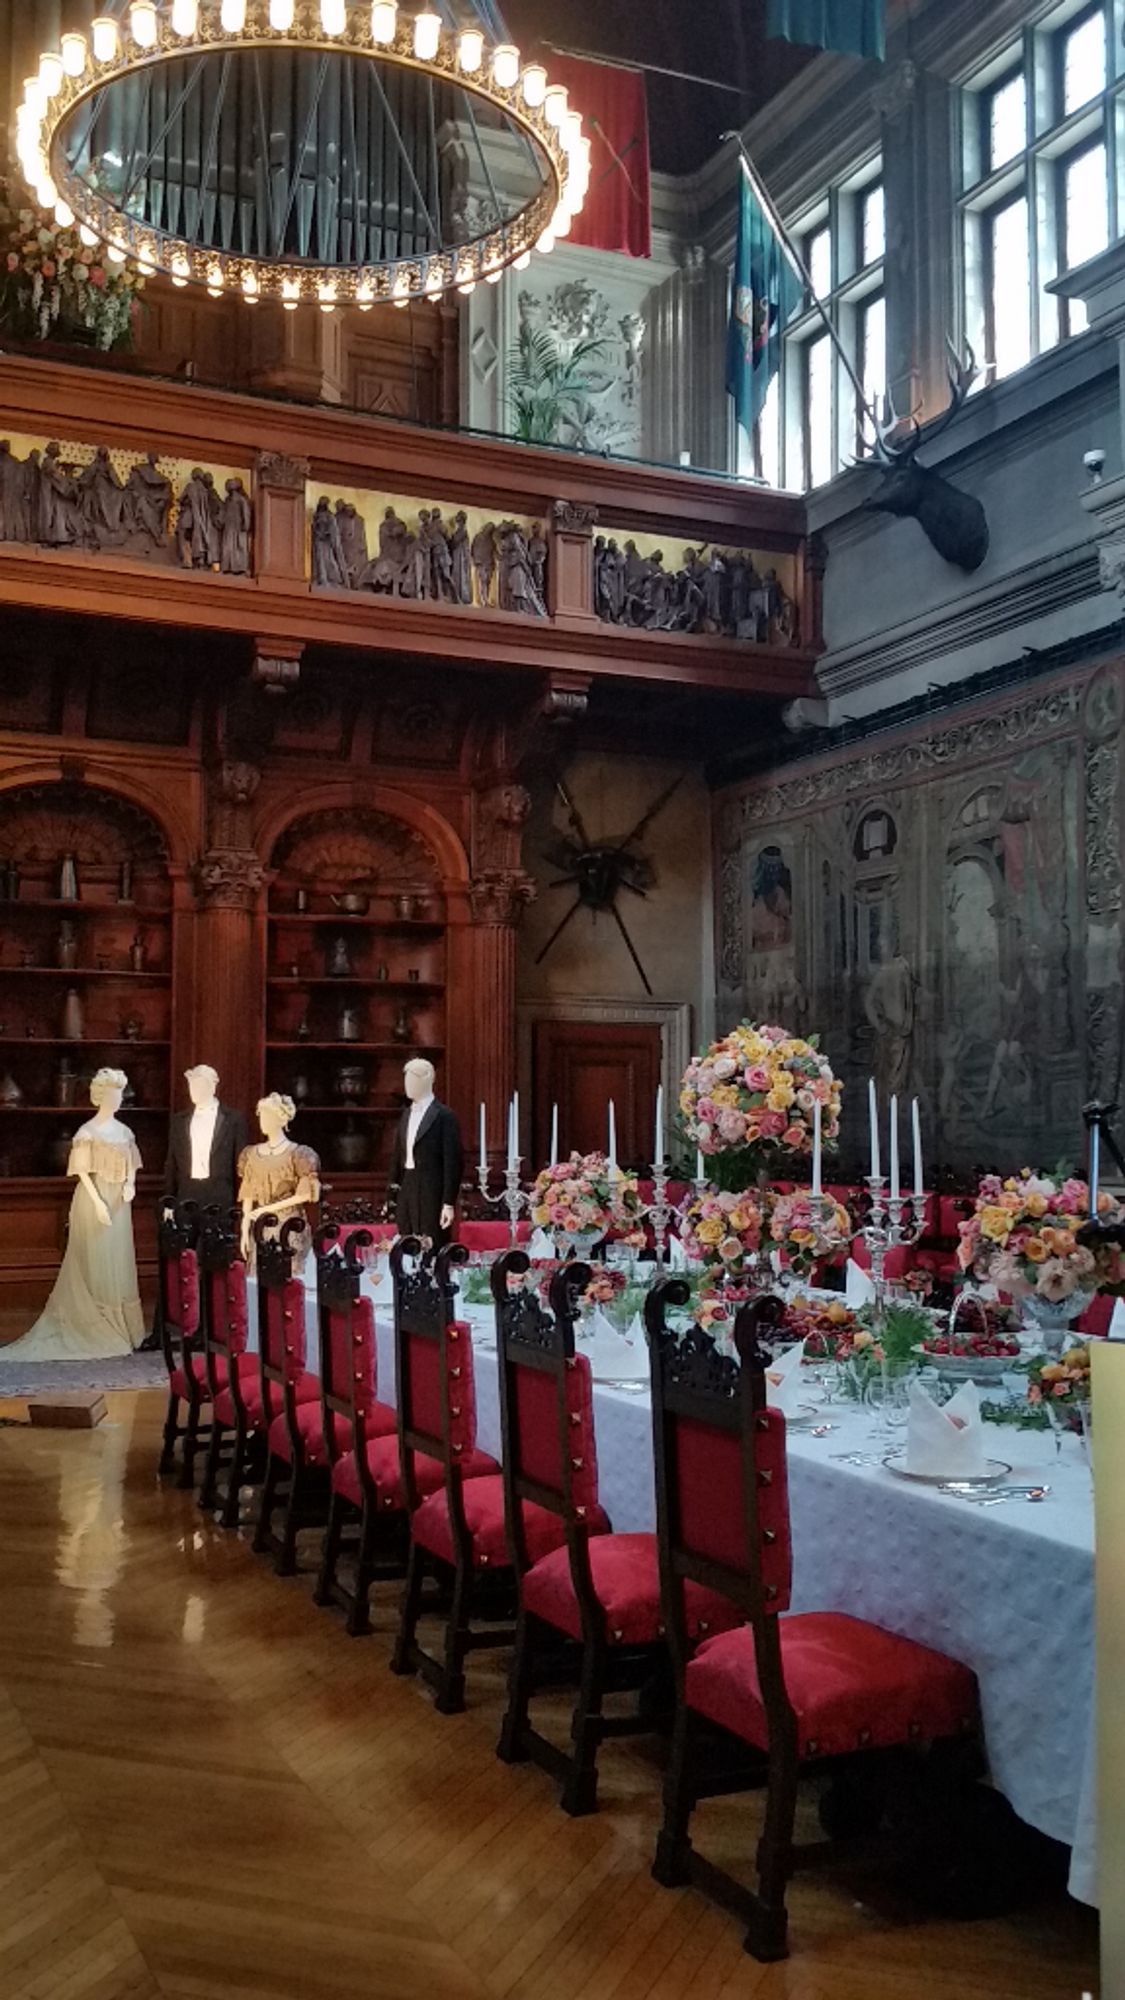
<box><xmin>16</xmin><ymin>0</ymin><xmax>589</xmax><ymax>312</ymax></box>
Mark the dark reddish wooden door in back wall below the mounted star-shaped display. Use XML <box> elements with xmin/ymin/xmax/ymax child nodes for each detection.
<box><xmin>532</xmin><ymin>1020</ymin><xmax>661</xmax><ymax>1170</ymax></box>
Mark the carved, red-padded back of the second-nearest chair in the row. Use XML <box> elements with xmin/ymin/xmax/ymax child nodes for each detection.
<box><xmin>492</xmin><ymin>1250</ymin><xmax>601</xmax><ymax>1630</ymax></box>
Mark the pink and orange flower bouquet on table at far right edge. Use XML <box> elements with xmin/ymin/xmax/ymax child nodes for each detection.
<box><xmin>957</xmin><ymin>1168</ymin><xmax>1119</xmax><ymax>1306</ymax></box>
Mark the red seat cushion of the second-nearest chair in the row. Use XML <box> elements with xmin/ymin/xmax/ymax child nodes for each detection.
<box><xmin>520</xmin><ymin>1534</ymin><xmax>743</xmax><ymax>1646</ymax></box>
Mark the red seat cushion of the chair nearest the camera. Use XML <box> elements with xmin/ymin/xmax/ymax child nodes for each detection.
<box><xmin>685</xmin><ymin>1612</ymin><xmax>977</xmax><ymax>1756</ymax></box>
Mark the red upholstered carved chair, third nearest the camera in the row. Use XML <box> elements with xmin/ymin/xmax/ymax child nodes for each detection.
<box><xmin>390</xmin><ymin>1224</ymin><xmax>504</xmax><ymax>1716</ymax></box>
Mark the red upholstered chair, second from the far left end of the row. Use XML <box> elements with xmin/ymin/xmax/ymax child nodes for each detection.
<box><xmin>196</xmin><ymin>1208</ymin><xmax>258</xmax><ymax>1528</ymax></box>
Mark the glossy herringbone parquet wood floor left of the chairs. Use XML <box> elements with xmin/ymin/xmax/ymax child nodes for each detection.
<box><xmin>0</xmin><ymin>1394</ymin><xmax>1097</xmax><ymax>2000</ymax></box>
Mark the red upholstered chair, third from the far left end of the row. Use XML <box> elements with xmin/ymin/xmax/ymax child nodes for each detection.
<box><xmin>254</xmin><ymin>1216</ymin><xmax>328</xmax><ymax>1576</ymax></box>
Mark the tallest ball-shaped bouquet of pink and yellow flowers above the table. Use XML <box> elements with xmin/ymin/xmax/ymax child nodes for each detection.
<box><xmin>681</xmin><ymin>1022</ymin><xmax>841</xmax><ymax>1186</ymax></box>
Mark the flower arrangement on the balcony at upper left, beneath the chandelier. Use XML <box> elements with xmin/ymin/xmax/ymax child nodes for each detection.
<box><xmin>0</xmin><ymin>180</ymin><xmax>144</xmax><ymax>352</ymax></box>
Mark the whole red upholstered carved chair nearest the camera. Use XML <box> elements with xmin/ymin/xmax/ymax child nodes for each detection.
<box><xmin>645</xmin><ymin>1278</ymin><xmax>977</xmax><ymax>1960</ymax></box>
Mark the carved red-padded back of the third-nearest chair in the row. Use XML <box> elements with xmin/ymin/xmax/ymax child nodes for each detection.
<box><xmin>390</xmin><ymin>1236</ymin><xmax>476</xmax><ymax>1528</ymax></box>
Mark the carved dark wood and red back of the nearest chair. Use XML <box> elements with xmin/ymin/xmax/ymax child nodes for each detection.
<box><xmin>645</xmin><ymin>1278</ymin><xmax>793</xmax><ymax>1724</ymax></box>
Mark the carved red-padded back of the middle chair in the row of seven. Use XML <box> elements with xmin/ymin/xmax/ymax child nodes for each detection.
<box><xmin>314</xmin><ymin>1224</ymin><xmax>376</xmax><ymax>1480</ymax></box>
